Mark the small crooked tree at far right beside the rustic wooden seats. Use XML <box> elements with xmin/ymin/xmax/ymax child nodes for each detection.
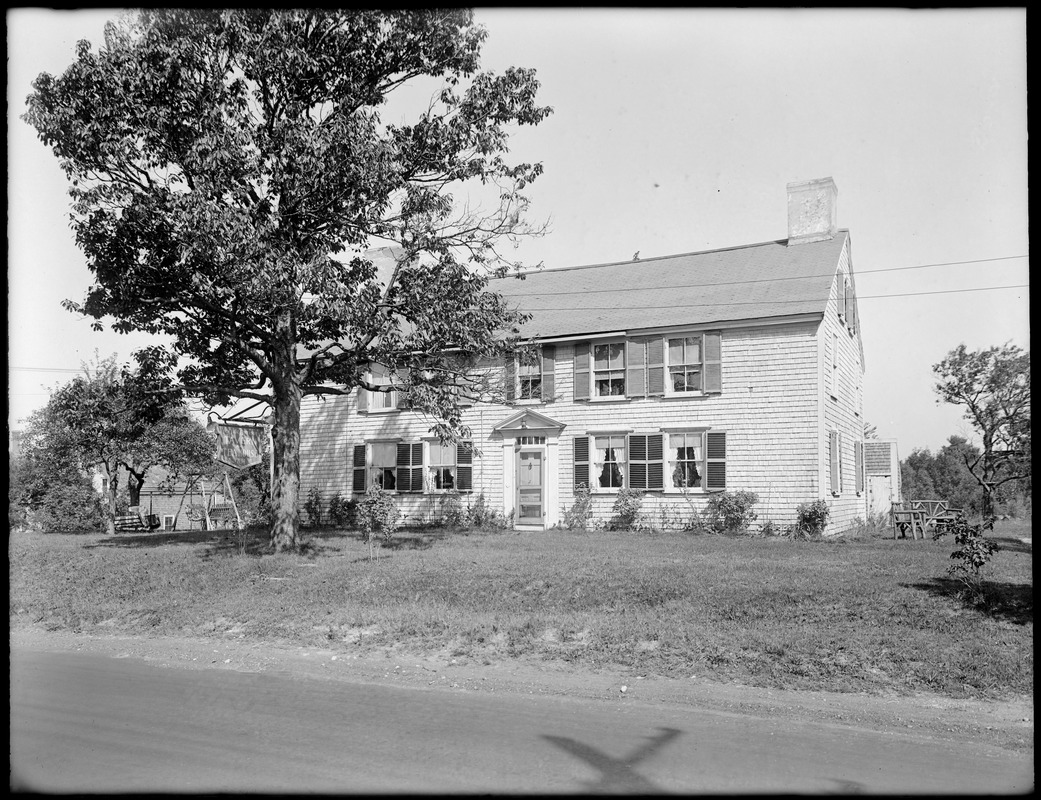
<box><xmin>933</xmin><ymin>344</ymin><xmax>1031</xmax><ymax>523</ymax></box>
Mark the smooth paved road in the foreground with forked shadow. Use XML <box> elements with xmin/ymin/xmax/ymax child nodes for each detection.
<box><xmin>10</xmin><ymin>647</ymin><xmax>1033</xmax><ymax>794</ymax></box>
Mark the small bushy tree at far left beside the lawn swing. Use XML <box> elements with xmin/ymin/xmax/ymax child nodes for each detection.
<box><xmin>23</xmin><ymin>356</ymin><xmax>181</xmax><ymax>533</ymax></box>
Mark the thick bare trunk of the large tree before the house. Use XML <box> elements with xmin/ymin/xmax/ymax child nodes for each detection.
<box><xmin>271</xmin><ymin>378</ymin><xmax>301</xmax><ymax>552</ymax></box>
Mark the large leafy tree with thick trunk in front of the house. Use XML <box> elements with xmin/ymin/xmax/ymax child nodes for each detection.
<box><xmin>25</xmin><ymin>9</ymin><xmax>550</xmax><ymax>550</ymax></box>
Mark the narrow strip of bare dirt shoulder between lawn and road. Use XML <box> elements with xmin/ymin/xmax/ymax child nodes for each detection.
<box><xmin>10</xmin><ymin>626</ymin><xmax>1034</xmax><ymax>751</ymax></box>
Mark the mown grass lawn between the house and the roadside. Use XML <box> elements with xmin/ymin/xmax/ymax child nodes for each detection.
<box><xmin>9</xmin><ymin>523</ymin><xmax>1034</xmax><ymax>698</ymax></box>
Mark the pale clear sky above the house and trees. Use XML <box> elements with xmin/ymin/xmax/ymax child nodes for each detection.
<box><xmin>6</xmin><ymin>8</ymin><xmax>1030</xmax><ymax>457</ymax></box>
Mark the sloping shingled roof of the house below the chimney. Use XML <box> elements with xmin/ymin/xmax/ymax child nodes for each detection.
<box><xmin>489</xmin><ymin>229</ymin><xmax>849</xmax><ymax>339</ymax></box>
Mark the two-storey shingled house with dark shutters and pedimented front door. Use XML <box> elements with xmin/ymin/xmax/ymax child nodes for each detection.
<box><xmin>301</xmin><ymin>178</ymin><xmax>867</xmax><ymax>531</ymax></box>
